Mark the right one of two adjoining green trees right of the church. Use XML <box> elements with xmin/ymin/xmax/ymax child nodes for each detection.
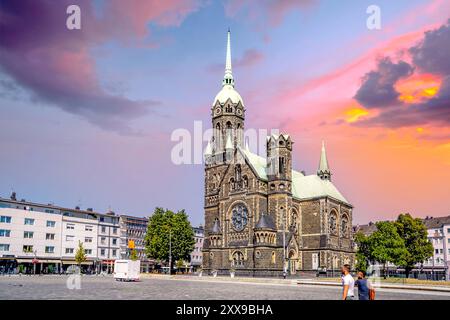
<box><xmin>395</xmin><ymin>213</ymin><xmax>433</xmax><ymax>278</ymax></box>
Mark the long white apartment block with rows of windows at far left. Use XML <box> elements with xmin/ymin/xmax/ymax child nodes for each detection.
<box><xmin>0</xmin><ymin>193</ymin><xmax>120</xmax><ymax>273</ymax></box>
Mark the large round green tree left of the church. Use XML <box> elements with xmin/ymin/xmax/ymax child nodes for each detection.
<box><xmin>145</xmin><ymin>208</ymin><xmax>195</xmax><ymax>270</ymax></box>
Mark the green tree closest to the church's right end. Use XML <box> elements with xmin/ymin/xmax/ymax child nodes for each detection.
<box><xmin>368</xmin><ymin>221</ymin><xmax>407</xmax><ymax>278</ymax></box>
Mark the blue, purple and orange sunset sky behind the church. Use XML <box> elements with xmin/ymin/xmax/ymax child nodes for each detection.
<box><xmin>0</xmin><ymin>0</ymin><xmax>450</xmax><ymax>225</ymax></box>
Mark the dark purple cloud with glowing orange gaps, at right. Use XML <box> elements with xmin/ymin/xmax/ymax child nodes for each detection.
<box><xmin>355</xmin><ymin>20</ymin><xmax>450</xmax><ymax>128</ymax></box>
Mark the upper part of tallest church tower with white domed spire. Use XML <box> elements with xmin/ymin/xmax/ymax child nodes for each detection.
<box><xmin>211</xmin><ymin>30</ymin><xmax>245</xmax><ymax>163</ymax></box>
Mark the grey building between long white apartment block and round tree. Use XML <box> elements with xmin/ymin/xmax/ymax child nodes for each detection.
<box><xmin>120</xmin><ymin>215</ymin><xmax>154</xmax><ymax>272</ymax></box>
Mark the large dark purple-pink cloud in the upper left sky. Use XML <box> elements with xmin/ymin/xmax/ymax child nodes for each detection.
<box><xmin>0</xmin><ymin>0</ymin><xmax>196</xmax><ymax>133</ymax></box>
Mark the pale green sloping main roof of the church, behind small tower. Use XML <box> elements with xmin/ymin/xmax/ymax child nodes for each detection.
<box><xmin>238</xmin><ymin>146</ymin><xmax>350</xmax><ymax>204</ymax></box>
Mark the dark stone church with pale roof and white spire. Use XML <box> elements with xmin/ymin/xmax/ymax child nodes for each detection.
<box><xmin>203</xmin><ymin>31</ymin><xmax>355</xmax><ymax>276</ymax></box>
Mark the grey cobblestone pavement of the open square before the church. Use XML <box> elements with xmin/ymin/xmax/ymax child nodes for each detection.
<box><xmin>0</xmin><ymin>276</ymin><xmax>450</xmax><ymax>300</ymax></box>
